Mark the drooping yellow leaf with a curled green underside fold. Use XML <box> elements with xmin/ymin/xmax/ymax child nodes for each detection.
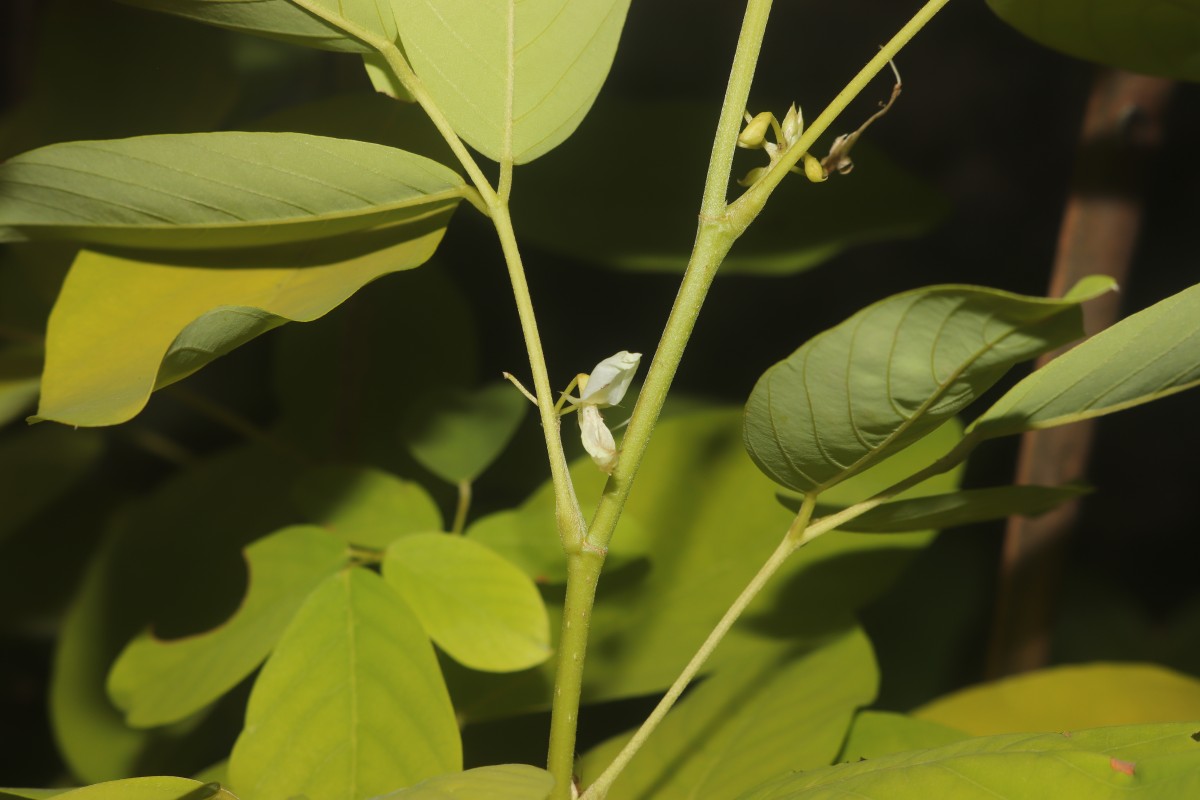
<box><xmin>37</xmin><ymin>224</ymin><xmax>444</xmax><ymax>426</ymax></box>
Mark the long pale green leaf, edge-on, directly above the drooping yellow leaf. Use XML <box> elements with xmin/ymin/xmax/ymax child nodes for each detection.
<box><xmin>0</xmin><ymin>131</ymin><xmax>467</xmax><ymax>249</ymax></box>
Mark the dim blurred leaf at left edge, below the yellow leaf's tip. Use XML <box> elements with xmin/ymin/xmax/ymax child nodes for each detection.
<box><xmin>0</xmin><ymin>427</ymin><xmax>103</xmax><ymax>541</ymax></box>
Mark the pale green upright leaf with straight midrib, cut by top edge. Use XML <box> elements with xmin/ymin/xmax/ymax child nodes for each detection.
<box><xmin>392</xmin><ymin>0</ymin><xmax>629</xmax><ymax>164</ymax></box>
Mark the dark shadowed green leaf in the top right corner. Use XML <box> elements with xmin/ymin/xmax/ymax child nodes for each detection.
<box><xmin>988</xmin><ymin>0</ymin><xmax>1200</xmax><ymax>80</ymax></box>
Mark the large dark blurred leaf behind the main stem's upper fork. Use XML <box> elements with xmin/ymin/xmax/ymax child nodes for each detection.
<box><xmin>512</xmin><ymin>98</ymin><xmax>946</xmax><ymax>275</ymax></box>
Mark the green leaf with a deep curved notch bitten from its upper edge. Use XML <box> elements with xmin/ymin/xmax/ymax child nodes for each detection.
<box><xmin>108</xmin><ymin>525</ymin><xmax>347</xmax><ymax>728</ymax></box>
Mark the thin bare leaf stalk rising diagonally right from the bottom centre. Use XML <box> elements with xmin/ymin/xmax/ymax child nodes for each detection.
<box><xmin>581</xmin><ymin>495</ymin><xmax>816</xmax><ymax>800</ymax></box>
